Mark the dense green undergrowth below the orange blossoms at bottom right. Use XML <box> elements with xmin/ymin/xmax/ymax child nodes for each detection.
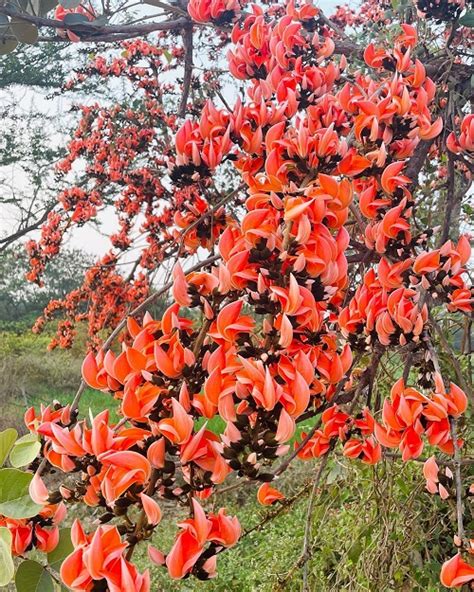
<box><xmin>129</xmin><ymin>457</ymin><xmax>455</xmax><ymax>592</ymax></box>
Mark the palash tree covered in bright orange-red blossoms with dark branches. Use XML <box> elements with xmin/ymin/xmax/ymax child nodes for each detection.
<box><xmin>0</xmin><ymin>0</ymin><xmax>474</xmax><ymax>591</ymax></box>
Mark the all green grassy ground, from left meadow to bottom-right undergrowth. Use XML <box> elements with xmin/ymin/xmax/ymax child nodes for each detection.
<box><xmin>0</xmin><ymin>331</ymin><xmax>464</xmax><ymax>592</ymax></box>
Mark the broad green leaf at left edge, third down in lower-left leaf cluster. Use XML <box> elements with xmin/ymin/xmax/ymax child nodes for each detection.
<box><xmin>0</xmin><ymin>469</ymin><xmax>43</xmax><ymax>519</ymax></box>
